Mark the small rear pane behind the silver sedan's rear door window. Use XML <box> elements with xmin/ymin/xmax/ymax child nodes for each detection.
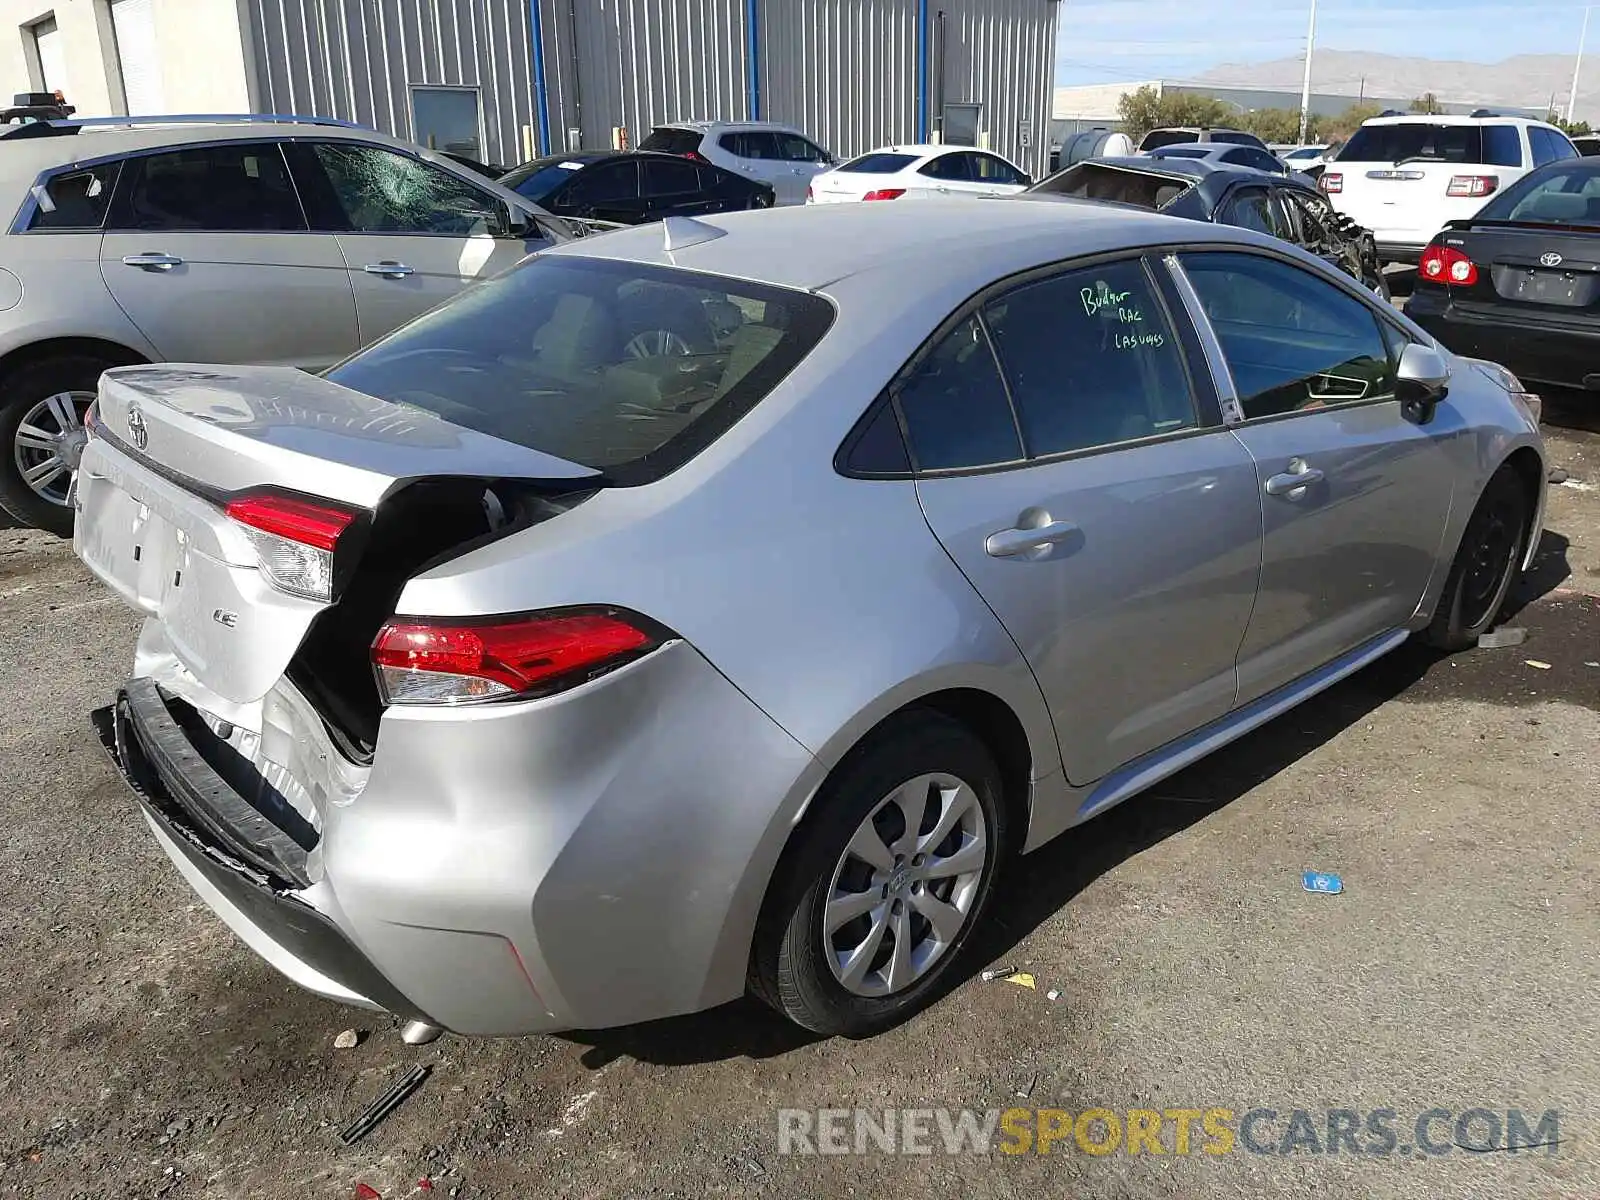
<box><xmin>894</xmin><ymin>317</ymin><xmax>1022</xmax><ymax>470</ymax></box>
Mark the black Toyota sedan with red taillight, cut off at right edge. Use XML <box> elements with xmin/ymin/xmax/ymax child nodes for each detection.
<box><xmin>1406</xmin><ymin>158</ymin><xmax>1600</xmax><ymax>390</ymax></box>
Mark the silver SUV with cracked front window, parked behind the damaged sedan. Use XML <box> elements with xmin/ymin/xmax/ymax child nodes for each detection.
<box><xmin>0</xmin><ymin>117</ymin><xmax>566</xmax><ymax>534</ymax></box>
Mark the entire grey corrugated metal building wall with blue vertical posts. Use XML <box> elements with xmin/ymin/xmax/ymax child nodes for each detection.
<box><xmin>246</xmin><ymin>0</ymin><xmax>1061</xmax><ymax>173</ymax></box>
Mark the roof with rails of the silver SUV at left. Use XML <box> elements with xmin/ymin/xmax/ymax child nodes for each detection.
<box><xmin>0</xmin><ymin>118</ymin><xmax>421</xmax><ymax>184</ymax></box>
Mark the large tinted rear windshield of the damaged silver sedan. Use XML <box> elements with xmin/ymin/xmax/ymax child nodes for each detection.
<box><xmin>328</xmin><ymin>256</ymin><xmax>834</xmax><ymax>485</ymax></box>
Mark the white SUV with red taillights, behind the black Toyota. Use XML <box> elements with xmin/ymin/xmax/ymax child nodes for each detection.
<box><xmin>1318</xmin><ymin>110</ymin><xmax>1578</xmax><ymax>262</ymax></box>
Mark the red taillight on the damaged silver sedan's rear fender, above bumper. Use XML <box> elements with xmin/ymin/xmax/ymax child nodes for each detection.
<box><xmin>373</xmin><ymin>608</ymin><xmax>666</xmax><ymax>704</ymax></box>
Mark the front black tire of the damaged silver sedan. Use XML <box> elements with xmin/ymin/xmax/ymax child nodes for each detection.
<box><xmin>1427</xmin><ymin>466</ymin><xmax>1533</xmax><ymax>651</ymax></box>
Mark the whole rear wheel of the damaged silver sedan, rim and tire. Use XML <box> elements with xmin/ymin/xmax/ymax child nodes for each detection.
<box><xmin>752</xmin><ymin>712</ymin><xmax>1006</xmax><ymax>1037</ymax></box>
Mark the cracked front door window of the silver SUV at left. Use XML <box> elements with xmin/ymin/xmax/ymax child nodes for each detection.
<box><xmin>315</xmin><ymin>142</ymin><xmax>499</xmax><ymax>237</ymax></box>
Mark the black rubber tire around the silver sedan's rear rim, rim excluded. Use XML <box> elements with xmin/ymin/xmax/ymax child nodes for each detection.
<box><xmin>750</xmin><ymin>712</ymin><xmax>1008</xmax><ymax>1037</ymax></box>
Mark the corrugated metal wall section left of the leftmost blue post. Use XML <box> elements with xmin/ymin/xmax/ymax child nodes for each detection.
<box><xmin>248</xmin><ymin>0</ymin><xmax>536</xmax><ymax>162</ymax></box>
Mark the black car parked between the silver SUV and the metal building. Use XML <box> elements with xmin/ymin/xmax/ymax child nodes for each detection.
<box><xmin>501</xmin><ymin>150</ymin><xmax>774</xmax><ymax>226</ymax></box>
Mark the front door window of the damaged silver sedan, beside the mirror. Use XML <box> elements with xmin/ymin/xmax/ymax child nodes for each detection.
<box><xmin>1182</xmin><ymin>253</ymin><xmax>1395</xmax><ymax>419</ymax></box>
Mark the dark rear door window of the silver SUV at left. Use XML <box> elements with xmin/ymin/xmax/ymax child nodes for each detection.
<box><xmin>107</xmin><ymin>142</ymin><xmax>306</xmax><ymax>234</ymax></box>
